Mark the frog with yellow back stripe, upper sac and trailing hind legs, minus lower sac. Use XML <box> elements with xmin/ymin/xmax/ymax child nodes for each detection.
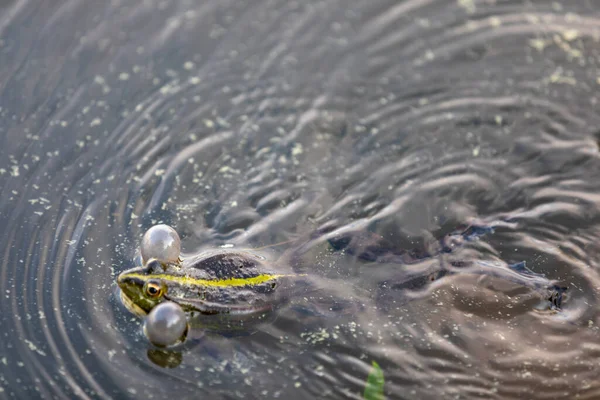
<box><xmin>117</xmin><ymin>225</ymin><xmax>566</xmax><ymax>326</ymax></box>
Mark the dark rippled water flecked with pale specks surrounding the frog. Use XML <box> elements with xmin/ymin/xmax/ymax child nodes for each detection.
<box><xmin>0</xmin><ymin>0</ymin><xmax>600</xmax><ymax>399</ymax></box>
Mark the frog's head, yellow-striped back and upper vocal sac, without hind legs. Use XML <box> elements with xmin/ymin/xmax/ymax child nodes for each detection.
<box><xmin>117</xmin><ymin>225</ymin><xmax>300</xmax><ymax>316</ymax></box>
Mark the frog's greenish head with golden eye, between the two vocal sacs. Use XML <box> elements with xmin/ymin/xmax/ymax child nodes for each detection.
<box><xmin>117</xmin><ymin>259</ymin><xmax>168</xmax><ymax>316</ymax></box>
